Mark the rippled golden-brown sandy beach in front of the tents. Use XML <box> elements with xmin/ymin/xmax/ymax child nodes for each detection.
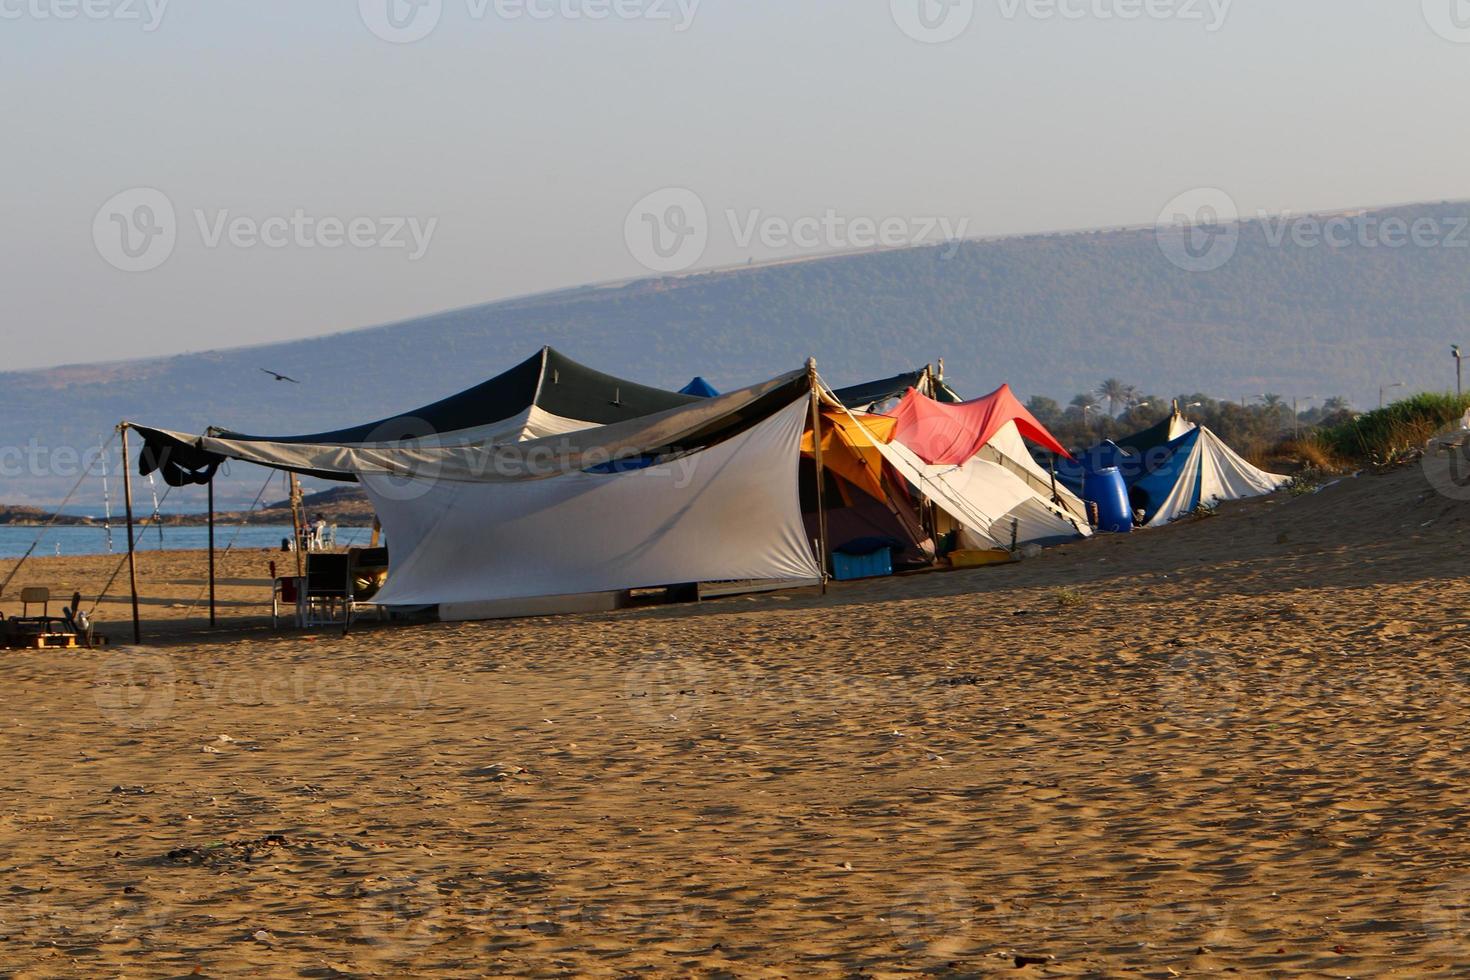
<box><xmin>0</xmin><ymin>469</ymin><xmax>1470</xmax><ymax>977</ymax></box>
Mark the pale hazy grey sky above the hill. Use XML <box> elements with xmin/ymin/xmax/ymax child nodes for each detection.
<box><xmin>0</xmin><ymin>0</ymin><xmax>1470</xmax><ymax>367</ymax></box>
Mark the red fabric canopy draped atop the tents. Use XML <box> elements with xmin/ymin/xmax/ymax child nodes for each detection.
<box><xmin>889</xmin><ymin>385</ymin><xmax>1072</xmax><ymax>466</ymax></box>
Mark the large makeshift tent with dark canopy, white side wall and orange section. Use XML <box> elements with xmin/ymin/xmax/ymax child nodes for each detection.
<box><xmin>131</xmin><ymin>348</ymin><xmax>1086</xmax><ymax>620</ymax></box>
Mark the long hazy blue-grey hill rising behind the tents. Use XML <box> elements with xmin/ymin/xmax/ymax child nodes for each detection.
<box><xmin>0</xmin><ymin>196</ymin><xmax>1470</xmax><ymax>507</ymax></box>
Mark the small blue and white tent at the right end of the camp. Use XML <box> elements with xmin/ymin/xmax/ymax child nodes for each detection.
<box><xmin>1057</xmin><ymin>403</ymin><xmax>1291</xmax><ymax>527</ymax></box>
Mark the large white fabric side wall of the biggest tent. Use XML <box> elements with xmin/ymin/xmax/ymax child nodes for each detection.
<box><xmin>359</xmin><ymin>398</ymin><xmax>822</xmax><ymax>605</ymax></box>
